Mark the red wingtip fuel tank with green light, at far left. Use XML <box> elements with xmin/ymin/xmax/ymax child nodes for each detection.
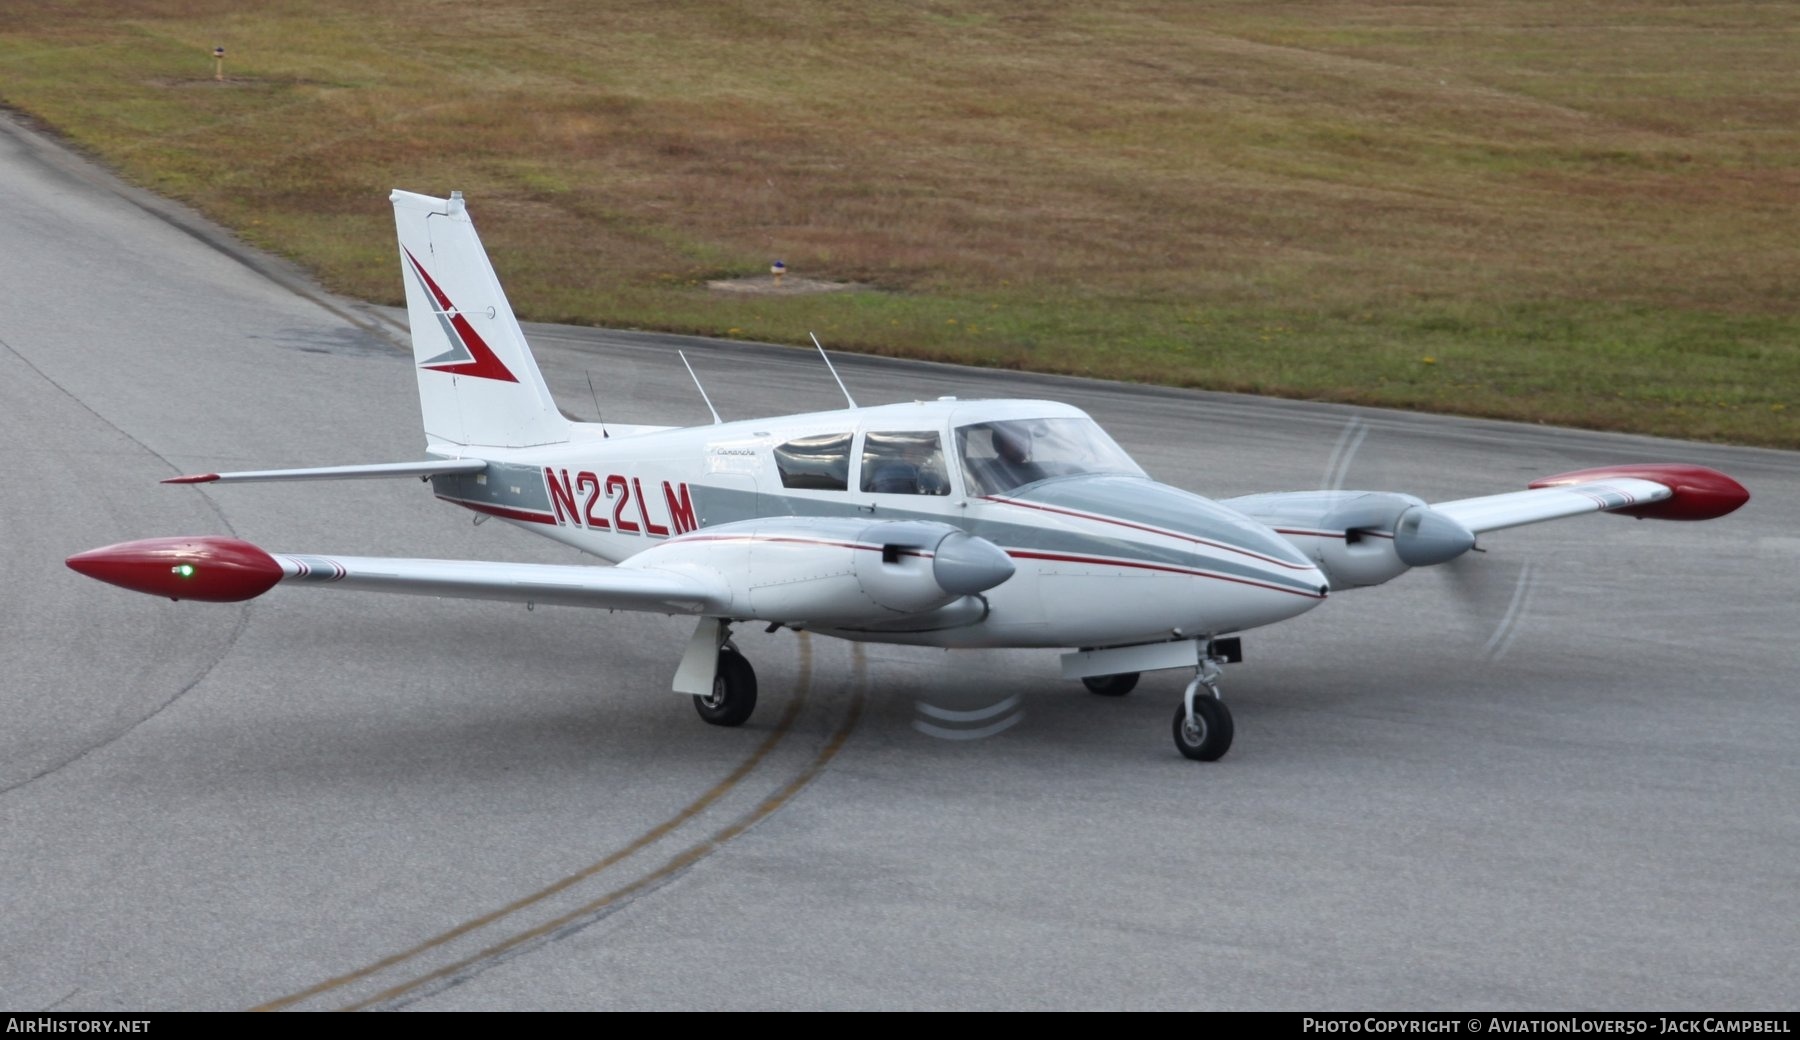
<box><xmin>68</xmin><ymin>536</ymin><xmax>283</xmax><ymax>603</ymax></box>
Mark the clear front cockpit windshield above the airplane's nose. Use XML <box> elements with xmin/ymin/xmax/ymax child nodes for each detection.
<box><xmin>956</xmin><ymin>419</ymin><xmax>1145</xmax><ymax>495</ymax></box>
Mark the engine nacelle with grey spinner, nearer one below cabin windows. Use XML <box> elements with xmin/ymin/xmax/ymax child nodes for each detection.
<box><xmin>621</xmin><ymin>516</ymin><xmax>1013</xmax><ymax>626</ymax></box>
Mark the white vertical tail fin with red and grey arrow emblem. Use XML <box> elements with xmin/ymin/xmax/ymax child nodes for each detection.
<box><xmin>389</xmin><ymin>191</ymin><xmax>569</xmax><ymax>448</ymax></box>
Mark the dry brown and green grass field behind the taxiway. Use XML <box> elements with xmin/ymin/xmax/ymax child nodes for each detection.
<box><xmin>0</xmin><ymin>0</ymin><xmax>1800</xmax><ymax>444</ymax></box>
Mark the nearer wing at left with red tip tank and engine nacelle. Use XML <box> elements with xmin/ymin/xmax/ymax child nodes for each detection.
<box><xmin>68</xmin><ymin>516</ymin><xmax>1013</xmax><ymax>626</ymax></box>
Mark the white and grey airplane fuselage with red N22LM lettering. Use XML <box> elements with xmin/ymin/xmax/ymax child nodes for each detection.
<box><xmin>432</xmin><ymin>399</ymin><xmax>1327</xmax><ymax>648</ymax></box>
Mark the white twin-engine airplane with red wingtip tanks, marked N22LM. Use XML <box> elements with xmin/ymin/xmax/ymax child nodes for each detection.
<box><xmin>68</xmin><ymin>191</ymin><xmax>1750</xmax><ymax>761</ymax></box>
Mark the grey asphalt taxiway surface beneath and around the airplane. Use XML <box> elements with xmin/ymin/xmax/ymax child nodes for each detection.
<box><xmin>0</xmin><ymin>113</ymin><xmax>1800</xmax><ymax>1009</ymax></box>
